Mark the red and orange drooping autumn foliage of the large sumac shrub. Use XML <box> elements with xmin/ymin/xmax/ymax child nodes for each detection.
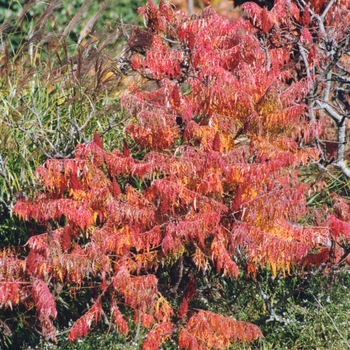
<box><xmin>0</xmin><ymin>0</ymin><xmax>349</xmax><ymax>350</ymax></box>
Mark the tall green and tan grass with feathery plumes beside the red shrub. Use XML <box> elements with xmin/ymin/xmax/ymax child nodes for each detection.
<box><xmin>0</xmin><ymin>1</ymin><xmax>146</xmax><ymax>242</ymax></box>
